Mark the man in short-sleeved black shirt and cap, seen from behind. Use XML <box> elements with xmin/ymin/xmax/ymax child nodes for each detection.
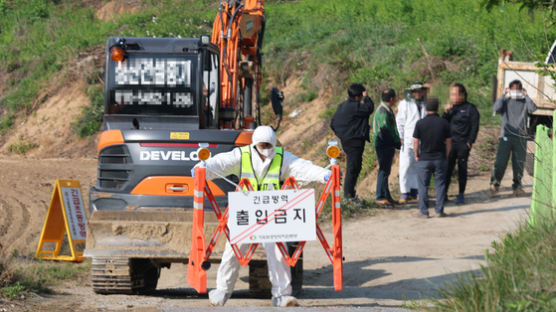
<box><xmin>413</xmin><ymin>98</ymin><xmax>452</xmax><ymax>218</ymax></box>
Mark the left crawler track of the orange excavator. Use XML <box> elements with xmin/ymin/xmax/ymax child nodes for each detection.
<box><xmin>91</xmin><ymin>257</ymin><xmax>160</xmax><ymax>294</ymax></box>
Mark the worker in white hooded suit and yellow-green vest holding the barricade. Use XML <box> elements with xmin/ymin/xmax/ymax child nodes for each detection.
<box><xmin>197</xmin><ymin>126</ymin><xmax>331</xmax><ymax>307</ymax></box>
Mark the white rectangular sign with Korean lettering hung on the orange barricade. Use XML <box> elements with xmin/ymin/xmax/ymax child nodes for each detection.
<box><xmin>228</xmin><ymin>189</ymin><xmax>317</xmax><ymax>244</ymax></box>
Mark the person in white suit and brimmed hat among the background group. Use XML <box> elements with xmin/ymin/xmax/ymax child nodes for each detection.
<box><xmin>396</xmin><ymin>81</ymin><xmax>427</xmax><ymax>203</ymax></box>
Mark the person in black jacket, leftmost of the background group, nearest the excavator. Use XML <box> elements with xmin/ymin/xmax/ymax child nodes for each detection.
<box><xmin>330</xmin><ymin>83</ymin><xmax>374</xmax><ymax>199</ymax></box>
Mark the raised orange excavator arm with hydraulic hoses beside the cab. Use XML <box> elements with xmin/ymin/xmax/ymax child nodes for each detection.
<box><xmin>211</xmin><ymin>0</ymin><xmax>265</xmax><ymax>129</ymax></box>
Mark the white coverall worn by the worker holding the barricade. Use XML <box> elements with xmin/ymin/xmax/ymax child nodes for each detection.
<box><xmin>200</xmin><ymin>137</ymin><xmax>330</xmax><ymax>297</ymax></box>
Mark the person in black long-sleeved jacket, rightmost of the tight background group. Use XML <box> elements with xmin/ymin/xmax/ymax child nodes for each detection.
<box><xmin>443</xmin><ymin>83</ymin><xmax>480</xmax><ymax>205</ymax></box>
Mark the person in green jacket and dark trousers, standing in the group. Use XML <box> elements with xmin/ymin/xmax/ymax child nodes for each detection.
<box><xmin>373</xmin><ymin>89</ymin><xmax>401</xmax><ymax>205</ymax></box>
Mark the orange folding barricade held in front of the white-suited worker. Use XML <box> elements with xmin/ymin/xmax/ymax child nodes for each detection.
<box><xmin>187</xmin><ymin>165</ymin><xmax>343</xmax><ymax>293</ymax></box>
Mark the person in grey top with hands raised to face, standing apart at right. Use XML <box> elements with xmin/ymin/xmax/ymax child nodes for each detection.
<box><xmin>490</xmin><ymin>80</ymin><xmax>537</xmax><ymax>197</ymax></box>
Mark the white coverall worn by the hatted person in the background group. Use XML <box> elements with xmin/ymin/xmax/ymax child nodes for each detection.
<box><xmin>396</xmin><ymin>98</ymin><xmax>426</xmax><ymax>194</ymax></box>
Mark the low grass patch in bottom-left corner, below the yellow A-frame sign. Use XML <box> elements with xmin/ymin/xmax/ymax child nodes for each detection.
<box><xmin>0</xmin><ymin>252</ymin><xmax>90</xmax><ymax>299</ymax></box>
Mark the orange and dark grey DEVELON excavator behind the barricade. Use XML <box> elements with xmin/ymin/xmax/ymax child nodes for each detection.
<box><xmin>84</xmin><ymin>0</ymin><xmax>296</xmax><ymax>295</ymax></box>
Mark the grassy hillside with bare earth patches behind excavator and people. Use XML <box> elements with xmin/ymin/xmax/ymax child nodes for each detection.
<box><xmin>0</xmin><ymin>0</ymin><xmax>556</xmax><ymax>182</ymax></box>
